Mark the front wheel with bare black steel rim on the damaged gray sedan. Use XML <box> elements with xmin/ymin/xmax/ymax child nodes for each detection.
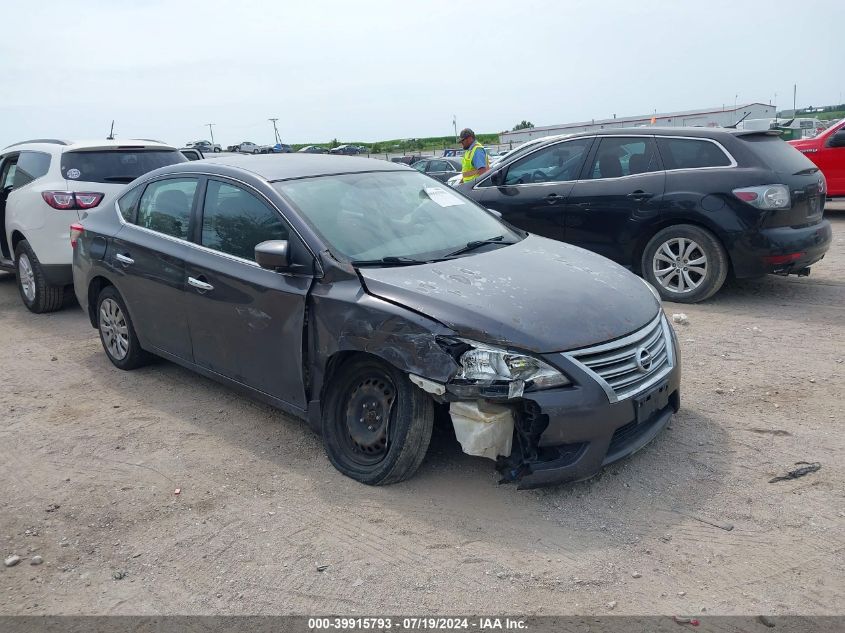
<box><xmin>322</xmin><ymin>357</ymin><xmax>434</xmax><ymax>486</ymax></box>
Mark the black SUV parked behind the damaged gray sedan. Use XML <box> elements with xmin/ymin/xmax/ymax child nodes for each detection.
<box><xmin>456</xmin><ymin>128</ymin><xmax>831</xmax><ymax>303</ymax></box>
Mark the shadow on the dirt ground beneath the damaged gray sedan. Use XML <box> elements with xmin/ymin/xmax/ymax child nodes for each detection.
<box><xmin>76</xmin><ymin>340</ymin><xmax>728</xmax><ymax>552</ymax></box>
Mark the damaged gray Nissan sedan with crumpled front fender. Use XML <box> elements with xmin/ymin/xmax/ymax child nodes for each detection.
<box><xmin>71</xmin><ymin>154</ymin><xmax>680</xmax><ymax>488</ymax></box>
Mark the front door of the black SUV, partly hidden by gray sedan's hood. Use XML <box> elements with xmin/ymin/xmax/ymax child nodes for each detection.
<box><xmin>469</xmin><ymin>138</ymin><xmax>593</xmax><ymax>240</ymax></box>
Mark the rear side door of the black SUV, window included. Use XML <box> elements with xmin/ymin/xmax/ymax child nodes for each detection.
<box><xmin>565</xmin><ymin>136</ymin><xmax>666</xmax><ymax>265</ymax></box>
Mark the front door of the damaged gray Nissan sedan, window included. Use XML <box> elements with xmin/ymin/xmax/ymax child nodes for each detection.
<box><xmin>181</xmin><ymin>179</ymin><xmax>312</xmax><ymax>409</ymax></box>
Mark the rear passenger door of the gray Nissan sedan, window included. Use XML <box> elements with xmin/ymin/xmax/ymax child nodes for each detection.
<box><xmin>105</xmin><ymin>177</ymin><xmax>195</xmax><ymax>361</ymax></box>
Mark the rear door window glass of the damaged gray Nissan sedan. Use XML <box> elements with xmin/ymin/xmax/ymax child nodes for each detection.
<box><xmin>136</xmin><ymin>178</ymin><xmax>198</xmax><ymax>240</ymax></box>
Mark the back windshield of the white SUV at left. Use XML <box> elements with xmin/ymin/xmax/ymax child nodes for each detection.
<box><xmin>61</xmin><ymin>149</ymin><xmax>188</xmax><ymax>183</ymax></box>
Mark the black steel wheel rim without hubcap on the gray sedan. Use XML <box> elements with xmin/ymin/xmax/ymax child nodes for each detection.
<box><xmin>341</xmin><ymin>370</ymin><xmax>396</xmax><ymax>466</ymax></box>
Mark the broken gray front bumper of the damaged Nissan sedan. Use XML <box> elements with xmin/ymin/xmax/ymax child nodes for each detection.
<box><xmin>500</xmin><ymin>316</ymin><xmax>681</xmax><ymax>488</ymax></box>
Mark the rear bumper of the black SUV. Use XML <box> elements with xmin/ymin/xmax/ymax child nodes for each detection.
<box><xmin>730</xmin><ymin>220</ymin><xmax>833</xmax><ymax>278</ymax></box>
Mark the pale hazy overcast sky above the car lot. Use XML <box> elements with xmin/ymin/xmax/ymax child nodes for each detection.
<box><xmin>0</xmin><ymin>0</ymin><xmax>845</xmax><ymax>147</ymax></box>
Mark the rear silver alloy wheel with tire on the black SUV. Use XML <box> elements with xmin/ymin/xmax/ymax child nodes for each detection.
<box><xmin>641</xmin><ymin>224</ymin><xmax>728</xmax><ymax>303</ymax></box>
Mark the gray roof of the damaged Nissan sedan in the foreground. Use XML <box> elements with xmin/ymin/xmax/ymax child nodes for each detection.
<box><xmin>168</xmin><ymin>153</ymin><xmax>408</xmax><ymax>182</ymax></box>
